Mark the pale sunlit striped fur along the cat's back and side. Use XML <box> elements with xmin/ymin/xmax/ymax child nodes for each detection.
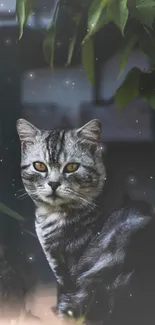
<box><xmin>72</xmin><ymin>208</ymin><xmax>151</xmax><ymax>285</ymax></box>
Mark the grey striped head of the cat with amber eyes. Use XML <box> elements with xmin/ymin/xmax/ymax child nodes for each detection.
<box><xmin>17</xmin><ymin>119</ymin><xmax>106</xmax><ymax>208</ymax></box>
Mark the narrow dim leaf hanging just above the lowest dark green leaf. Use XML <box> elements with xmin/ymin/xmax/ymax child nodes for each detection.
<box><xmin>118</xmin><ymin>34</ymin><xmax>138</xmax><ymax>79</ymax></box>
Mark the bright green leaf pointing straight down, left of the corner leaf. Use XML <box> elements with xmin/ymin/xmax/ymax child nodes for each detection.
<box><xmin>108</xmin><ymin>0</ymin><xmax>129</xmax><ymax>34</ymax></box>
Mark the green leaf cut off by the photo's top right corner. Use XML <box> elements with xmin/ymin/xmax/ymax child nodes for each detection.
<box><xmin>130</xmin><ymin>0</ymin><xmax>155</xmax><ymax>27</ymax></box>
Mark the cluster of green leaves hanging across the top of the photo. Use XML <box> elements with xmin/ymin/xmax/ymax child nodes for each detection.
<box><xmin>16</xmin><ymin>0</ymin><xmax>155</xmax><ymax>109</ymax></box>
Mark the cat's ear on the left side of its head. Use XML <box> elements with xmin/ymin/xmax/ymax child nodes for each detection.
<box><xmin>16</xmin><ymin>118</ymin><xmax>40</xmax><ymax>143</ymax></box>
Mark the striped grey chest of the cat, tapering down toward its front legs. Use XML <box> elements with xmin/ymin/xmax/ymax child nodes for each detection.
<box><xmin>35</xmin><ymin>211</ymin><xmax>92</xmax><ymax>284</ymax></box>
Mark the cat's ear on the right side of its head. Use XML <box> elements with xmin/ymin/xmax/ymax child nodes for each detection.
<box><xmin>77</xmin><ymin>119</ymin><xmax>101</xmax><ymax>143</ymax></box>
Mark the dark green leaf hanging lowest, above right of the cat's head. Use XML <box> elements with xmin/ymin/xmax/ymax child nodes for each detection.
<box><xmin>115</xmin><ymin>68</ymin><xmax>141</xmax><ymax>110</ymax></box>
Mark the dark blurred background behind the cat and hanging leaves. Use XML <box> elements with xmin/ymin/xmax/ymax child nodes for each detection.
<box><xmin>0</xmin><ymin>0</ymin><xmax>155</xmax><ymax>322</ymax></box>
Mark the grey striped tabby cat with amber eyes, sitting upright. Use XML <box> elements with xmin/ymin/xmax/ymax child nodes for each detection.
<box><xmin>17</xmin><ymin>119</ymin><xmax>150</xmax><ymax>319</ymax></box>
